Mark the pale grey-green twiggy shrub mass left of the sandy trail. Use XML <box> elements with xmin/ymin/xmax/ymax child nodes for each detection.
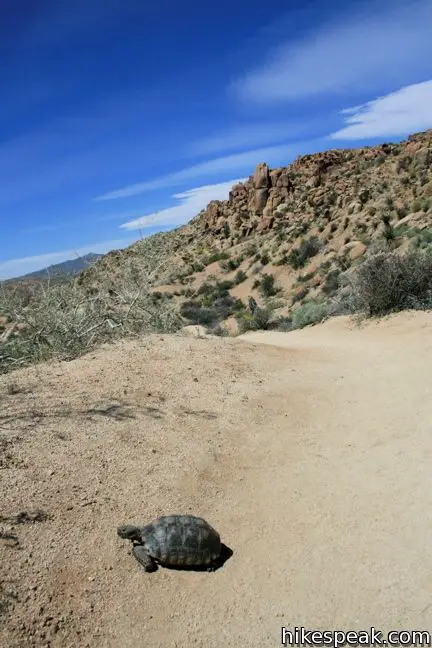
<box><xmin>0</xmin><ymin>278</ymin><xmax>182</xmax><ymax>373</ymax></box>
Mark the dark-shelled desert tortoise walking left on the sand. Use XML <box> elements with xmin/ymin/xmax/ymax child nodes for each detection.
<box><xmin>117</xmin><ymin>515</ymin><xmax>221</xmax><ymax>572</ymax></box>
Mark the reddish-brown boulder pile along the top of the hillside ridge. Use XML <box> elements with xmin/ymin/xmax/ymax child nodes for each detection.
<box><xmin>193</xmin><ymin>130</ymin><xmax>432</xmax><ymax>241</ymax></box>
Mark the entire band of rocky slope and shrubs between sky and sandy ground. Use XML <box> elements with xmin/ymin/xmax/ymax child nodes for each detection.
<box><xmin>0</xmin><ymin>130</ymin><xmax>432</xmax><ymax>371</ymax></box>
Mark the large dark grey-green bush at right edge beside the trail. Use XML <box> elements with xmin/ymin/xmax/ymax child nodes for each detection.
<box><xmin>349</xmin><ymin>248</ymin><xmax>432</xmax><ymax>317</ymax></box>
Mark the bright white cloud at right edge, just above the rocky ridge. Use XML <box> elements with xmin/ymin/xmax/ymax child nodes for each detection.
<box><xmin>330</xmin><ymin>80</ymin><xmax>432</xmax><ymax>140</ymax></box>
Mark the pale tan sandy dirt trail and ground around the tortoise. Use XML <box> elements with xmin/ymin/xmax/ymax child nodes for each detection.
<box><xmin>0</xmin><ymin>313</ymin><xmax>432</xmax><ymax>648</ymax></box>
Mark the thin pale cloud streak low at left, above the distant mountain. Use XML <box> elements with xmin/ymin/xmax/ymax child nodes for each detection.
<box><xmin>0</xmin><ymin>238</ymin><xmax>137</xmax><ymax>280</ymax></box>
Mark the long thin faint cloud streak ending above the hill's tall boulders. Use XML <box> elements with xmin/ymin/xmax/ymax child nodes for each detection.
<box><xmin>95</xmin><ymin>145</ymin><xmax>292</xmax><ymax>200</ymax></box>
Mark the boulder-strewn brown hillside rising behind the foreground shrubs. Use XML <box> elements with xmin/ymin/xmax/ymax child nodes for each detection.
<box><xmin>79</xmin><ymin>130</ymin><xmax>432</xmax><ymax>326</ymax></box>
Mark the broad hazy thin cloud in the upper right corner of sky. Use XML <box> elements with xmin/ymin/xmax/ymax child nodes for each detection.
<box><xmin>232</xmin><ymin>0</ymin><xmax>432</xmax><ymax>103</ymax></box>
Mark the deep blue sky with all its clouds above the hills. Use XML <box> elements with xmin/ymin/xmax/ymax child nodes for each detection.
<box><xmin>0</xmin><ymin>0</ymin><xmax>432</xmax><ymax>279</ymax></box>
